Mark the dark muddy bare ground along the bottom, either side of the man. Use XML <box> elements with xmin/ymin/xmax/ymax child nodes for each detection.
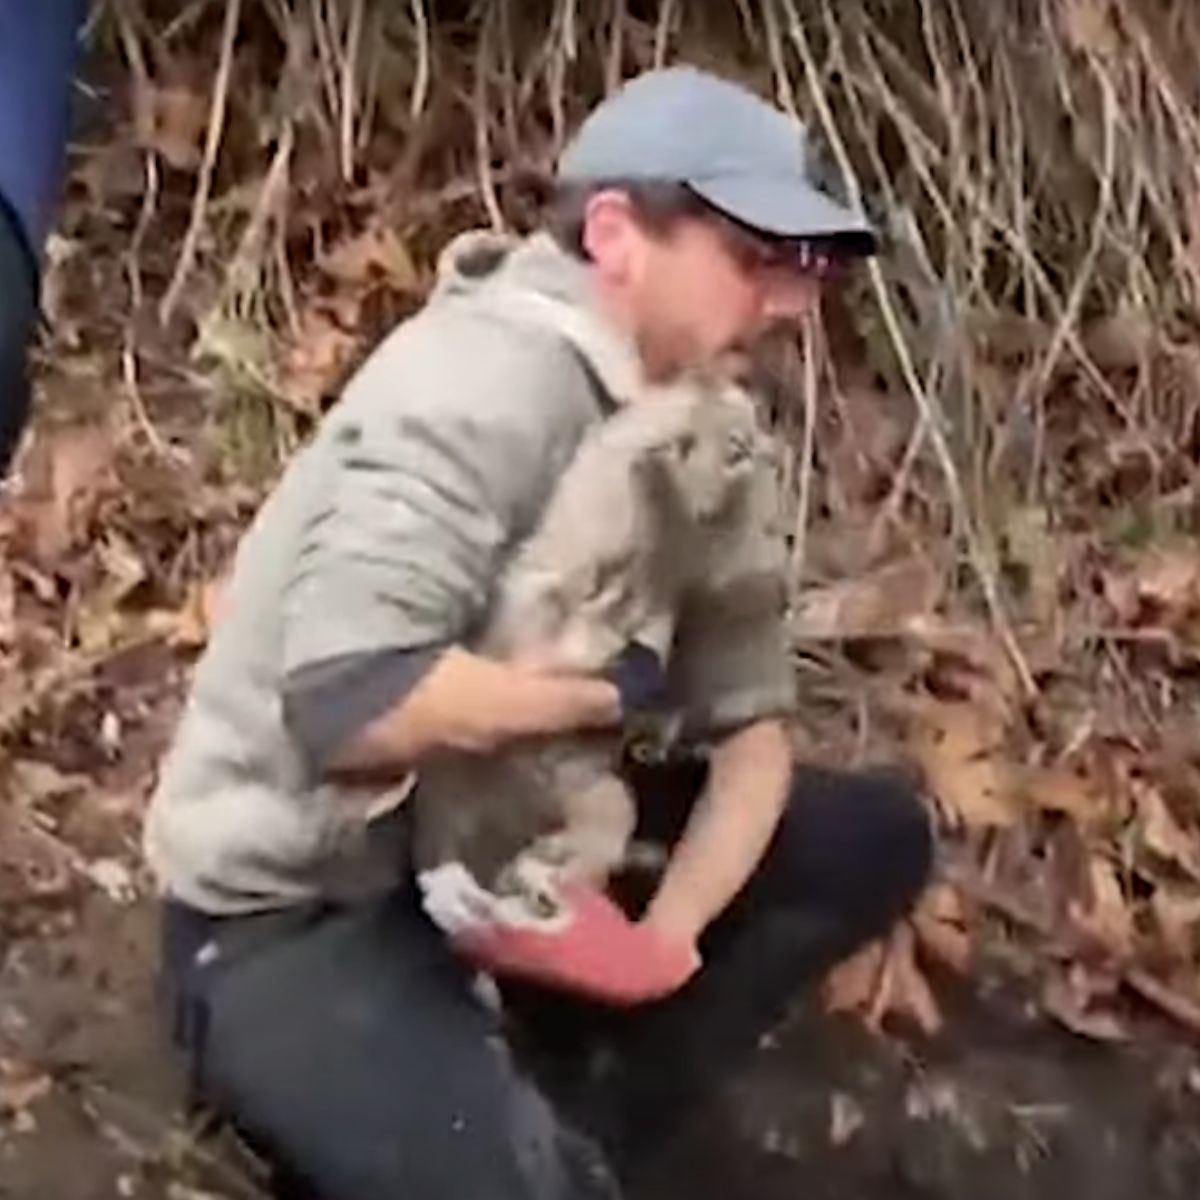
<box><xmin>0</xmin><ymin>868</ymin><xmax>1200</xmax><ymax>1200</ymax></box>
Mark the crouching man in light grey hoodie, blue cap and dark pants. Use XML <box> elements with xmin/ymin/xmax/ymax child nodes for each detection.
<box><xmin>146</xmin><ymin>68</ymin><xmax>930</xmax><ymax>1200</ymax></box>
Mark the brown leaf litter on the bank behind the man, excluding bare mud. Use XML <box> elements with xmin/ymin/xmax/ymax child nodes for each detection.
<box><xmin>9</xmin><ymin>0</ymin><xmax>1200</xmax><ymax>1195</ymax></box>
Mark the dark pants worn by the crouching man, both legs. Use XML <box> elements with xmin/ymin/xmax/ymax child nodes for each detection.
<box><xmin>159</xmin><ymin>764</ymin><xmax>932</xmax><ymax>1200</ymax></box>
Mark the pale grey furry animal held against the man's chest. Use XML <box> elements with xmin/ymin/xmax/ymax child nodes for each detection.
<box><xmin>413</xmin><ymin>369</ymin><xmax>755</xmax><ymax>901</ymax></box>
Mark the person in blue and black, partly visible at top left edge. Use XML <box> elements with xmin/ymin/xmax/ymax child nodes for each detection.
<box><xmin>0</xmin><ymin>0</ymin><xmax>88</xmax><ymax>475</ymax></box>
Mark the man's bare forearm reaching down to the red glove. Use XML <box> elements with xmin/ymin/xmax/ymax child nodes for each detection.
<box><xmin>643</xmin><ymin>721</ymin><xmax>792</xmax><ymax>944</ymax></box>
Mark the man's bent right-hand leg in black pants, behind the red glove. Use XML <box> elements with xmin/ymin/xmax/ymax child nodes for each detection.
<box><xmin>510</xmin><ymin>763</ymin><xmax>934</xmax><ymax>1168</ymax></box>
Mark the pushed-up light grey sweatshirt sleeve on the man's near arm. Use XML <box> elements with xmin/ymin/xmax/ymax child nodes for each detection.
<box><xmin>282</xmin><ymin>319</ymin><xmax>600</xmax><ymax>676</ymax></box>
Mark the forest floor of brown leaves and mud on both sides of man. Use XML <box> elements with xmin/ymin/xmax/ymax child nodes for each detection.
<box><xmin>11</xmin><ymin>0</ymin><xmax>1200</xmax><ymax>1200</ymax></box>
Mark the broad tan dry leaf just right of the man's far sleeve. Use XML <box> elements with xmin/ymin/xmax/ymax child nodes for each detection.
<box><xmin>792</xmin><ymin>558</ymin><xmax>941</xmax><ymax>641</ymax></box>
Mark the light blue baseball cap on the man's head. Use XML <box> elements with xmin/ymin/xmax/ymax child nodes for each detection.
<box><xmin>558</xmin><ymin>66</ymin><xmax>878</xmax><ymax>256</ymax></box>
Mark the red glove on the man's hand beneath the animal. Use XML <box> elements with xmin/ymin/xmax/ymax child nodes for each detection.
<box><xmin>452</xmin><ymin>883</ymin><xmax>700</xmax><ymax>1006</ymax></box>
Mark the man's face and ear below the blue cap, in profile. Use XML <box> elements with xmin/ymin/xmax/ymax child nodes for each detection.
<box><xmin>590</xmin><ymin>189</ymin><xmax>821</xmax><ymax>378</ymax></box>
